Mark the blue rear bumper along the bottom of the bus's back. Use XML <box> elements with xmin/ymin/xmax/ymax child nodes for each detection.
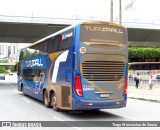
<box><xmin>73</xmin><ymin>99</ymin><xmax>126</xmax><ymax>110</ymax></box>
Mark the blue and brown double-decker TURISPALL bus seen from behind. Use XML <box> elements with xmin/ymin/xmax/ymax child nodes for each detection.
<box><xmin>18</xmin><ymin>21</ymin><xmax>128</xmax><ymax>111</ymax></box>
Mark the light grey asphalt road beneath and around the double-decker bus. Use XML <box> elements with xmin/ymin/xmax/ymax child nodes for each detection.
<box><xmin>0</xmin><ymin>81</ymin><xmax>160</xmax><ymax>130</ymax></box>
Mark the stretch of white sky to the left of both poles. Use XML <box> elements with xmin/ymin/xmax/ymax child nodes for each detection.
<box><xmin>0</xmin><ymin>0</ymin><xmax>109</xmax><ymax>17</ymax></box>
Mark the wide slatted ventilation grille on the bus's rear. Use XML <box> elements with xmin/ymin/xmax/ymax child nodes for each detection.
<box><xmin>82</xmin><ymin>61</ymin><xmax>124</xmax><ymax>81</ymax></box>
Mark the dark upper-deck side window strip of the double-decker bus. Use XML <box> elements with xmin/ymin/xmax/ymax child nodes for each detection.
<box><xmin>20</xmin><ymin>29</ymin><xmax>73</xmax><ymax>60</ymax></box>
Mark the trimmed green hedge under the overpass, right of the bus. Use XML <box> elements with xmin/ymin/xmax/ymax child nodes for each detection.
<box><xmin>128</xmin><ymin>47</ymin><xmax>160</xmax><ymax>58</ymax></box>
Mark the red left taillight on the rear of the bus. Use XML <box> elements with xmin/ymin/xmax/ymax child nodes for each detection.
<box><xmin>74</xmin><ymin>75</ymin><xmax>83</xmax><ymax>97</ymax></box>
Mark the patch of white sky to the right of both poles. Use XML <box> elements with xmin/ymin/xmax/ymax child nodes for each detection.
<box><xmin>122</xmin><ymin>0</ymin><xmax>160</xmax><ymax>22</ymax></box>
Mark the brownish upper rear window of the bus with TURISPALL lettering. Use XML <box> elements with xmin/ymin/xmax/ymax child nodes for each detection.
<box><xmin>80</xmin><ymin>24</ymin><xmax>126</xmax><ymax>47</ymax></box>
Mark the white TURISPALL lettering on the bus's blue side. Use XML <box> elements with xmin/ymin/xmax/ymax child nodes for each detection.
<box><xmin>26</xmin><ymin>59</ymin><xmax>43</xmax><ymax>67</ymax></box>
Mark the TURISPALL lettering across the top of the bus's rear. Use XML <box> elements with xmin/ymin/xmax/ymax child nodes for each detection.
<box><xmin>85</xmin><ymin>26</ymin><xmax>123</xmax><ymax>34</ymax></box>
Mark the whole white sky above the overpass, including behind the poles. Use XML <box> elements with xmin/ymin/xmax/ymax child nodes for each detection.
<box><xmin>0</xmin><ymin>0</ymin><xmax>160</xmax><ymax>22</ymax></box>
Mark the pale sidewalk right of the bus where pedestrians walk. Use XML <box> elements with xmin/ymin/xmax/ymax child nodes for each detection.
<box><xmin>127</xmin><ymin>85</ymin><xmax>160</xmax><ymax>103</ymax></box>
